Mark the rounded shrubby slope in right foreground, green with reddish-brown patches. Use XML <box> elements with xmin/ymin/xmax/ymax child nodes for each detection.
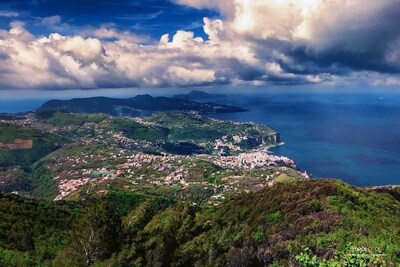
<box><xmin>122</xmin><ymin>180</ymin><xmax>400</xmax><ymax>266</ymax></box>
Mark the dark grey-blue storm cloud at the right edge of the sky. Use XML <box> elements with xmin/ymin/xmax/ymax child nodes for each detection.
<box><xmin>250</xmin><ymin>1</ymin><xmax>400</xmax><ymax>80</ymax></box>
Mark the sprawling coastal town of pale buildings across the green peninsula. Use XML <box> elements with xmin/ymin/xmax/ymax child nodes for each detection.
<box><xmin>0</xmin><ymin>112</ymin><xmax>308</xmax><ymax>205</ymax></box>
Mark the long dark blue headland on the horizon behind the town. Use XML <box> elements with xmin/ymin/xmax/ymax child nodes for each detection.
<box><xmin>36</xmin><ymin>95</ymin><xmax>246</xmax><ymax>117</ymax></box>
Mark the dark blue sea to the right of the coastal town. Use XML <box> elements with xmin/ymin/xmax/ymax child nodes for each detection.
<box><xmin>206</xmin><ymin>92</ymin><xmax>400</xmax><ymax>186</ymax></box>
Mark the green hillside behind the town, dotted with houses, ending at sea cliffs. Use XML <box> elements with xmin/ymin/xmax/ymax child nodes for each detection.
<box><xmin>33</xmin><ymin>111</ymin><xmax>280</xmax><ymax>154</ymax></box>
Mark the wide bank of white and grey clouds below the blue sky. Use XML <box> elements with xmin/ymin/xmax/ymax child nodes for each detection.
<box><xmin>0</xmin><ymin>0</ymin><xmax>400</xmax><ymax>89</ymax></box>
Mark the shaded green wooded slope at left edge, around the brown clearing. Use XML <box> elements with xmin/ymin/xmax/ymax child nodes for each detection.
<box><xmin>0</xmin><ymin>123</ymin><xmax>70</xmax><ymax>198</ymax></box>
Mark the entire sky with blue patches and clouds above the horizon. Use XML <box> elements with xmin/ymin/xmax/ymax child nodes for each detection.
<box><xmin>0</xmin><ymin>0</ymin><xmax>400</xmax><ymax>96</ymax></box>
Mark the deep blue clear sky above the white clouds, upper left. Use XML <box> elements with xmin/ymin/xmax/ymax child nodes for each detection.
<box><xmin>0</xmin><ymin>0</ymin><xmax>219</xmax><ymax>39</ymax></box>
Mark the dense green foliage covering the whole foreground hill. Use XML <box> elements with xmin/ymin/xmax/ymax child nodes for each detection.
<box><xmin>0</xmin><ymin>180</ymin><xmax>400</xmax><ymax>266</ymax></box>
